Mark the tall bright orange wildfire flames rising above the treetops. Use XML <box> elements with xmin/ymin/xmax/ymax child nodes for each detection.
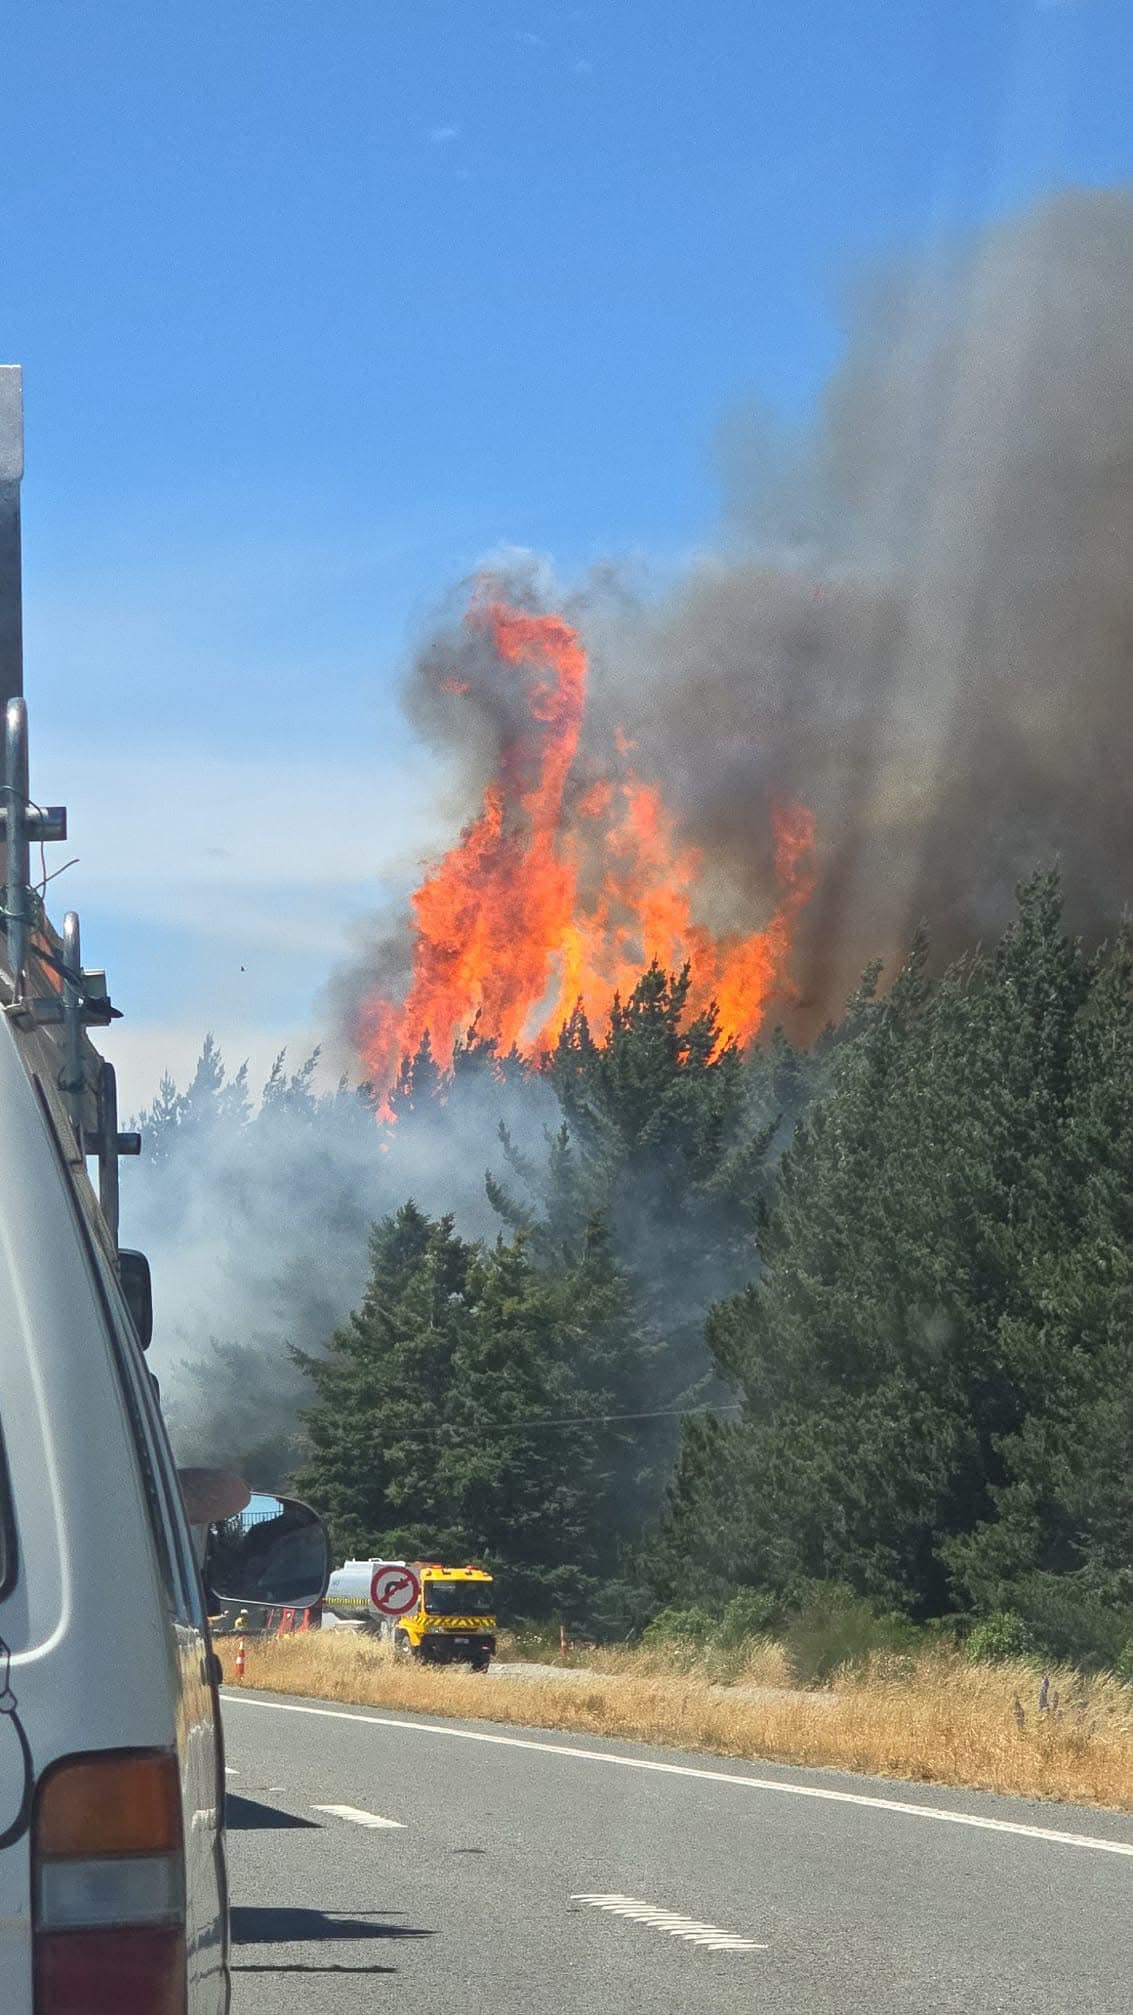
<box><xmin>355</xmin><ymin>598</ymin><xmax>814</xmax><ymax>1090</ymax></box>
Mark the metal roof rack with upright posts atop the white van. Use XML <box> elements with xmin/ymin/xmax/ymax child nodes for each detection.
<box><xmin>0</xmin><ymin>365</ymin><xmax>141</xmax><ymax>1251</ymax></box>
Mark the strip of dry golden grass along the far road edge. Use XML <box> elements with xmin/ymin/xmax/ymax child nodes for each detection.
<box><xmin>224</xmin><ymin>1630</ymin><xmax>1133</xmax><ymax>1811</ymax></box>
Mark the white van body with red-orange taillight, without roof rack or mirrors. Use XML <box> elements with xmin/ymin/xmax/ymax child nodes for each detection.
<box><xmin>0</xmin><ymin>995</ymin><xmax>228</xmax><ymax>2015</ymax></box>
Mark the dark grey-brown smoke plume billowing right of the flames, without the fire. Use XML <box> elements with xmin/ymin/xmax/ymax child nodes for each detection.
<box><xmin>339</xmin><ymin>189</ymin><xmax>1133</xmax><ymax>1032</ymax></box>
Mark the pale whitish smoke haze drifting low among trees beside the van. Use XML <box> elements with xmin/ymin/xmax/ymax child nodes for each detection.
<box><xmin>123</xmin><ymin>1046</ymin><xmax>558</xmax><ymax>1487</ymax></box>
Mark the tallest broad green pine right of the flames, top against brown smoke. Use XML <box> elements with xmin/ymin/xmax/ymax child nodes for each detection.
<box><xmin>653</xmin><ymin>877</ymin><xmax>1123</xmax><ymax>1616</ymax></box>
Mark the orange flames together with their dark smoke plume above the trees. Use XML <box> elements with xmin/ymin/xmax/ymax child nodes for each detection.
<box><xmin>337</xmin><ymin>191</ymin><xmax>1133</xmax><ymax>1090</ymax></box>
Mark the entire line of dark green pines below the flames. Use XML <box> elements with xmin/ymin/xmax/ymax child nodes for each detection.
<box><xmin>141</xmin><ymin>877</ymin><xmax>1133</xmax><ymax>1660</ymax></box>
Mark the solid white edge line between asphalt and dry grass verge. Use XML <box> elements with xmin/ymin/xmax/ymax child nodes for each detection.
<box><xmin>222</xmin><ymin>1693</ymin><xmax>1133</xmax><ymax>1856</ymax></box>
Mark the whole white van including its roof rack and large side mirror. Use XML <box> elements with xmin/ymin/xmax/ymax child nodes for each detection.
<box><xmin>0</xmin><ymin>362</ymin><xmax>329</xmax><ymax>2015</ymax></box>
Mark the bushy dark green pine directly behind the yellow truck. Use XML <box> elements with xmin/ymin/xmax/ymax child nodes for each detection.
<box><xmin>296</xmin><ymin>1205</ymin><xmax>639</xmax><ymax>1622</ymax></box>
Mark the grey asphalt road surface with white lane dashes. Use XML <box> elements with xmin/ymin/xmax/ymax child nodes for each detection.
<box><xmin>224</xmin><ymin>1693</ymin><xmax>1133</xmax><ymax>2015</ymax></box>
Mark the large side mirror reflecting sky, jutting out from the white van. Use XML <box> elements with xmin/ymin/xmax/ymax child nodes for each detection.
<box><xmin>204</xmin><ymin>1491</ymin><xmax>331</xmax><ymax>1610</ymax></box>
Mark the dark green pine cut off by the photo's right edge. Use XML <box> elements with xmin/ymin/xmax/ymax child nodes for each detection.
<box><xmin>950</xmin><ymin>939</ymin><xmax>1133</xmax><ymax>1660</ymax></box>
